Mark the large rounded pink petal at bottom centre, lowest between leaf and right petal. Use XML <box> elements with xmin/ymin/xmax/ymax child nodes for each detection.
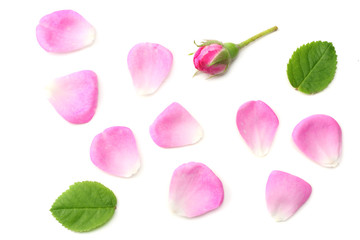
<box><xmin>169</xmin><ymin>162</ymin><xmax>224</xmax><ymax>218</ymax></box>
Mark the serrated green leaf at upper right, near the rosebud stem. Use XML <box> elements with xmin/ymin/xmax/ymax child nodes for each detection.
<box><xmin>287</xmin><ymin>41</ymin><xmax>337</xmax><ymax>94</ymax></box>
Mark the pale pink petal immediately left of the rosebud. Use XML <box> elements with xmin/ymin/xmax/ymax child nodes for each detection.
<box><xmin>127</xmin><ymin>43</ymin><xmax>173</xmax><ymax>95</ymax></box>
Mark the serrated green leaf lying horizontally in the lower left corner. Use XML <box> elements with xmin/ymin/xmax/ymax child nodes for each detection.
<box><xmin>50</xmin><ymin>181</ymin><xmax>117</xmax><ymax>232</ymax></box>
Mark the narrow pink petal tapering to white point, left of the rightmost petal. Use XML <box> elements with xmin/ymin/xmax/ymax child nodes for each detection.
<box><xmin>236</xmin><ymin>101</ymin><xmax>279</xmax><ymax>156</ymax></box>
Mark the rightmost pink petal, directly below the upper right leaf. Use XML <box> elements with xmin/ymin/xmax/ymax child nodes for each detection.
<box><xmin>292</xmin><ymin>114</ymin><xmax>342</xmax><ymax>167</ymax></box>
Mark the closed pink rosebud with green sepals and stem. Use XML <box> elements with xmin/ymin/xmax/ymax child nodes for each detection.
<box><xmin>194</xmin><ymin>26</ymin><xmax>278</xmax><ymax>76</ymax></box>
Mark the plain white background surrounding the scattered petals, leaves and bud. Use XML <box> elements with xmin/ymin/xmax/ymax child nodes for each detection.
<box><xmin>0</xmin><ymin>0</ymin><xmax>360</xmax><ymax>240</ymax></box>
